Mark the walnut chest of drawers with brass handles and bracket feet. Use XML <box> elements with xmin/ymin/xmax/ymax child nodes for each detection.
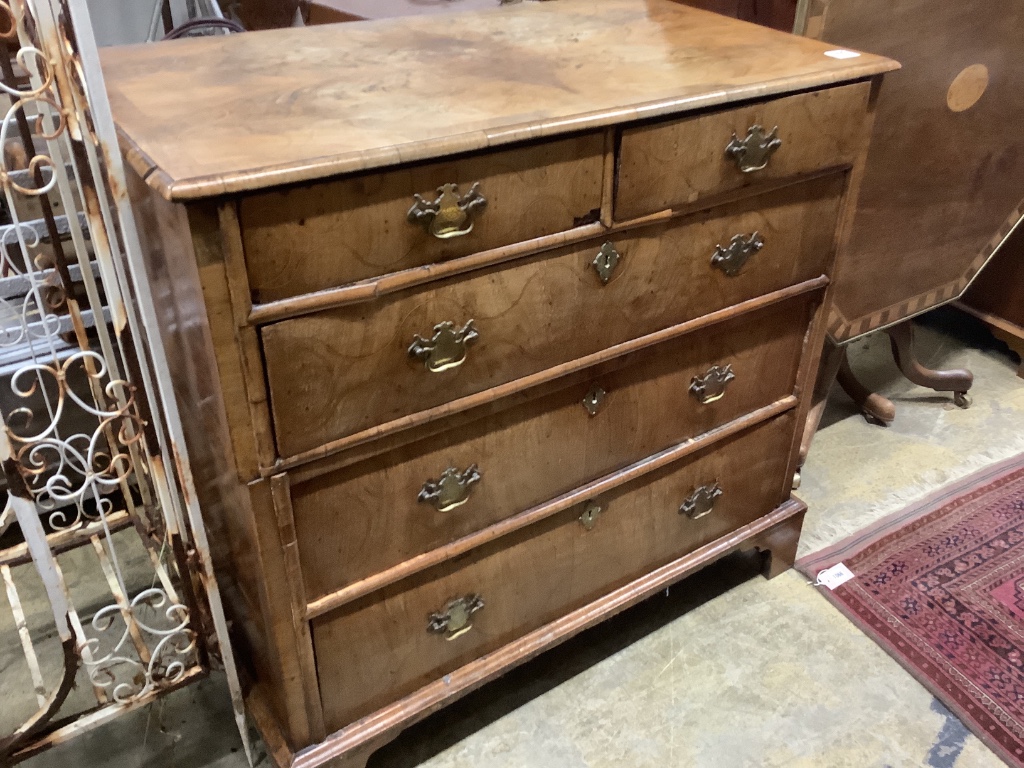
<box><xmin>103</xmin><ymin>0</ymin><xmax>896</xmax><ymax>766</ymax></box>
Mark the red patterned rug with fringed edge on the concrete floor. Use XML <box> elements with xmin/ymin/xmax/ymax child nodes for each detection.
<box><xmin>797</xmin><ymin>456</ymin><xmax>1024</xmax><ymax>768</ymax></box>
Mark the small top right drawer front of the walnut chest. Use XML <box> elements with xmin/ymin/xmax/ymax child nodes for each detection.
<box><xmin>614</xmin><ymin>83</ymin><xmax>870</xmax><ymax>221</ymax></box>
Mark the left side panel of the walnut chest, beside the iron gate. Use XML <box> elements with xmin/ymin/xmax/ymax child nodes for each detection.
<box><xmin>123</xmin><ymin>174</ymin><xmax>316</xmax><ymax>749</ymax></box>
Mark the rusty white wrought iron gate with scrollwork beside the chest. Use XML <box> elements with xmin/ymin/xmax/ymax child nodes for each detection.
<box><xmin>0</xmin><ymin>0</ymin><xmax>249</xmax><ymax>765</ymax></box>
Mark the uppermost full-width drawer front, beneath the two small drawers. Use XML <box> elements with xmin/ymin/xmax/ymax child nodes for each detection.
<box><xmin>262</xmin><ymin>176</ymin><xmax>845</xmax><ymax>457</ymax></box>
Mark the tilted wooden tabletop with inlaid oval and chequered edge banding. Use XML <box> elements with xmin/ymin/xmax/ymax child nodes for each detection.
<box><xmin>804</xmin><ymin>0</ymin><xmax>1024</xmax><ymax>341</ymax></box>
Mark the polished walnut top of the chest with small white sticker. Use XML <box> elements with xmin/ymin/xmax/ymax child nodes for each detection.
<box><xmin>102</xmin><ymin>0</ymin><xmax>897</xmax><ymax>200</ymax></box>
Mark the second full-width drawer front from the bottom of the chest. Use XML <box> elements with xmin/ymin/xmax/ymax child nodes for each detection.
<box><xmin>292</xmin><ymin>299</ymin><xmax>811</xmax><ymax>599</ymax></box>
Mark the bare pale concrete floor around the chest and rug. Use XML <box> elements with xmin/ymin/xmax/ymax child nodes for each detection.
<box><xmin>14</xmin><ymin>310</ymin><xmax>1024</xmax><ymax>768</ymax></box>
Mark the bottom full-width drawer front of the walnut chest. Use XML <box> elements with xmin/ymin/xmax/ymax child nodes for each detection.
<box><xmin>312</xmin><ymin>413</ymin><xmax>795</xmax><ymax>731</ymax></box>
